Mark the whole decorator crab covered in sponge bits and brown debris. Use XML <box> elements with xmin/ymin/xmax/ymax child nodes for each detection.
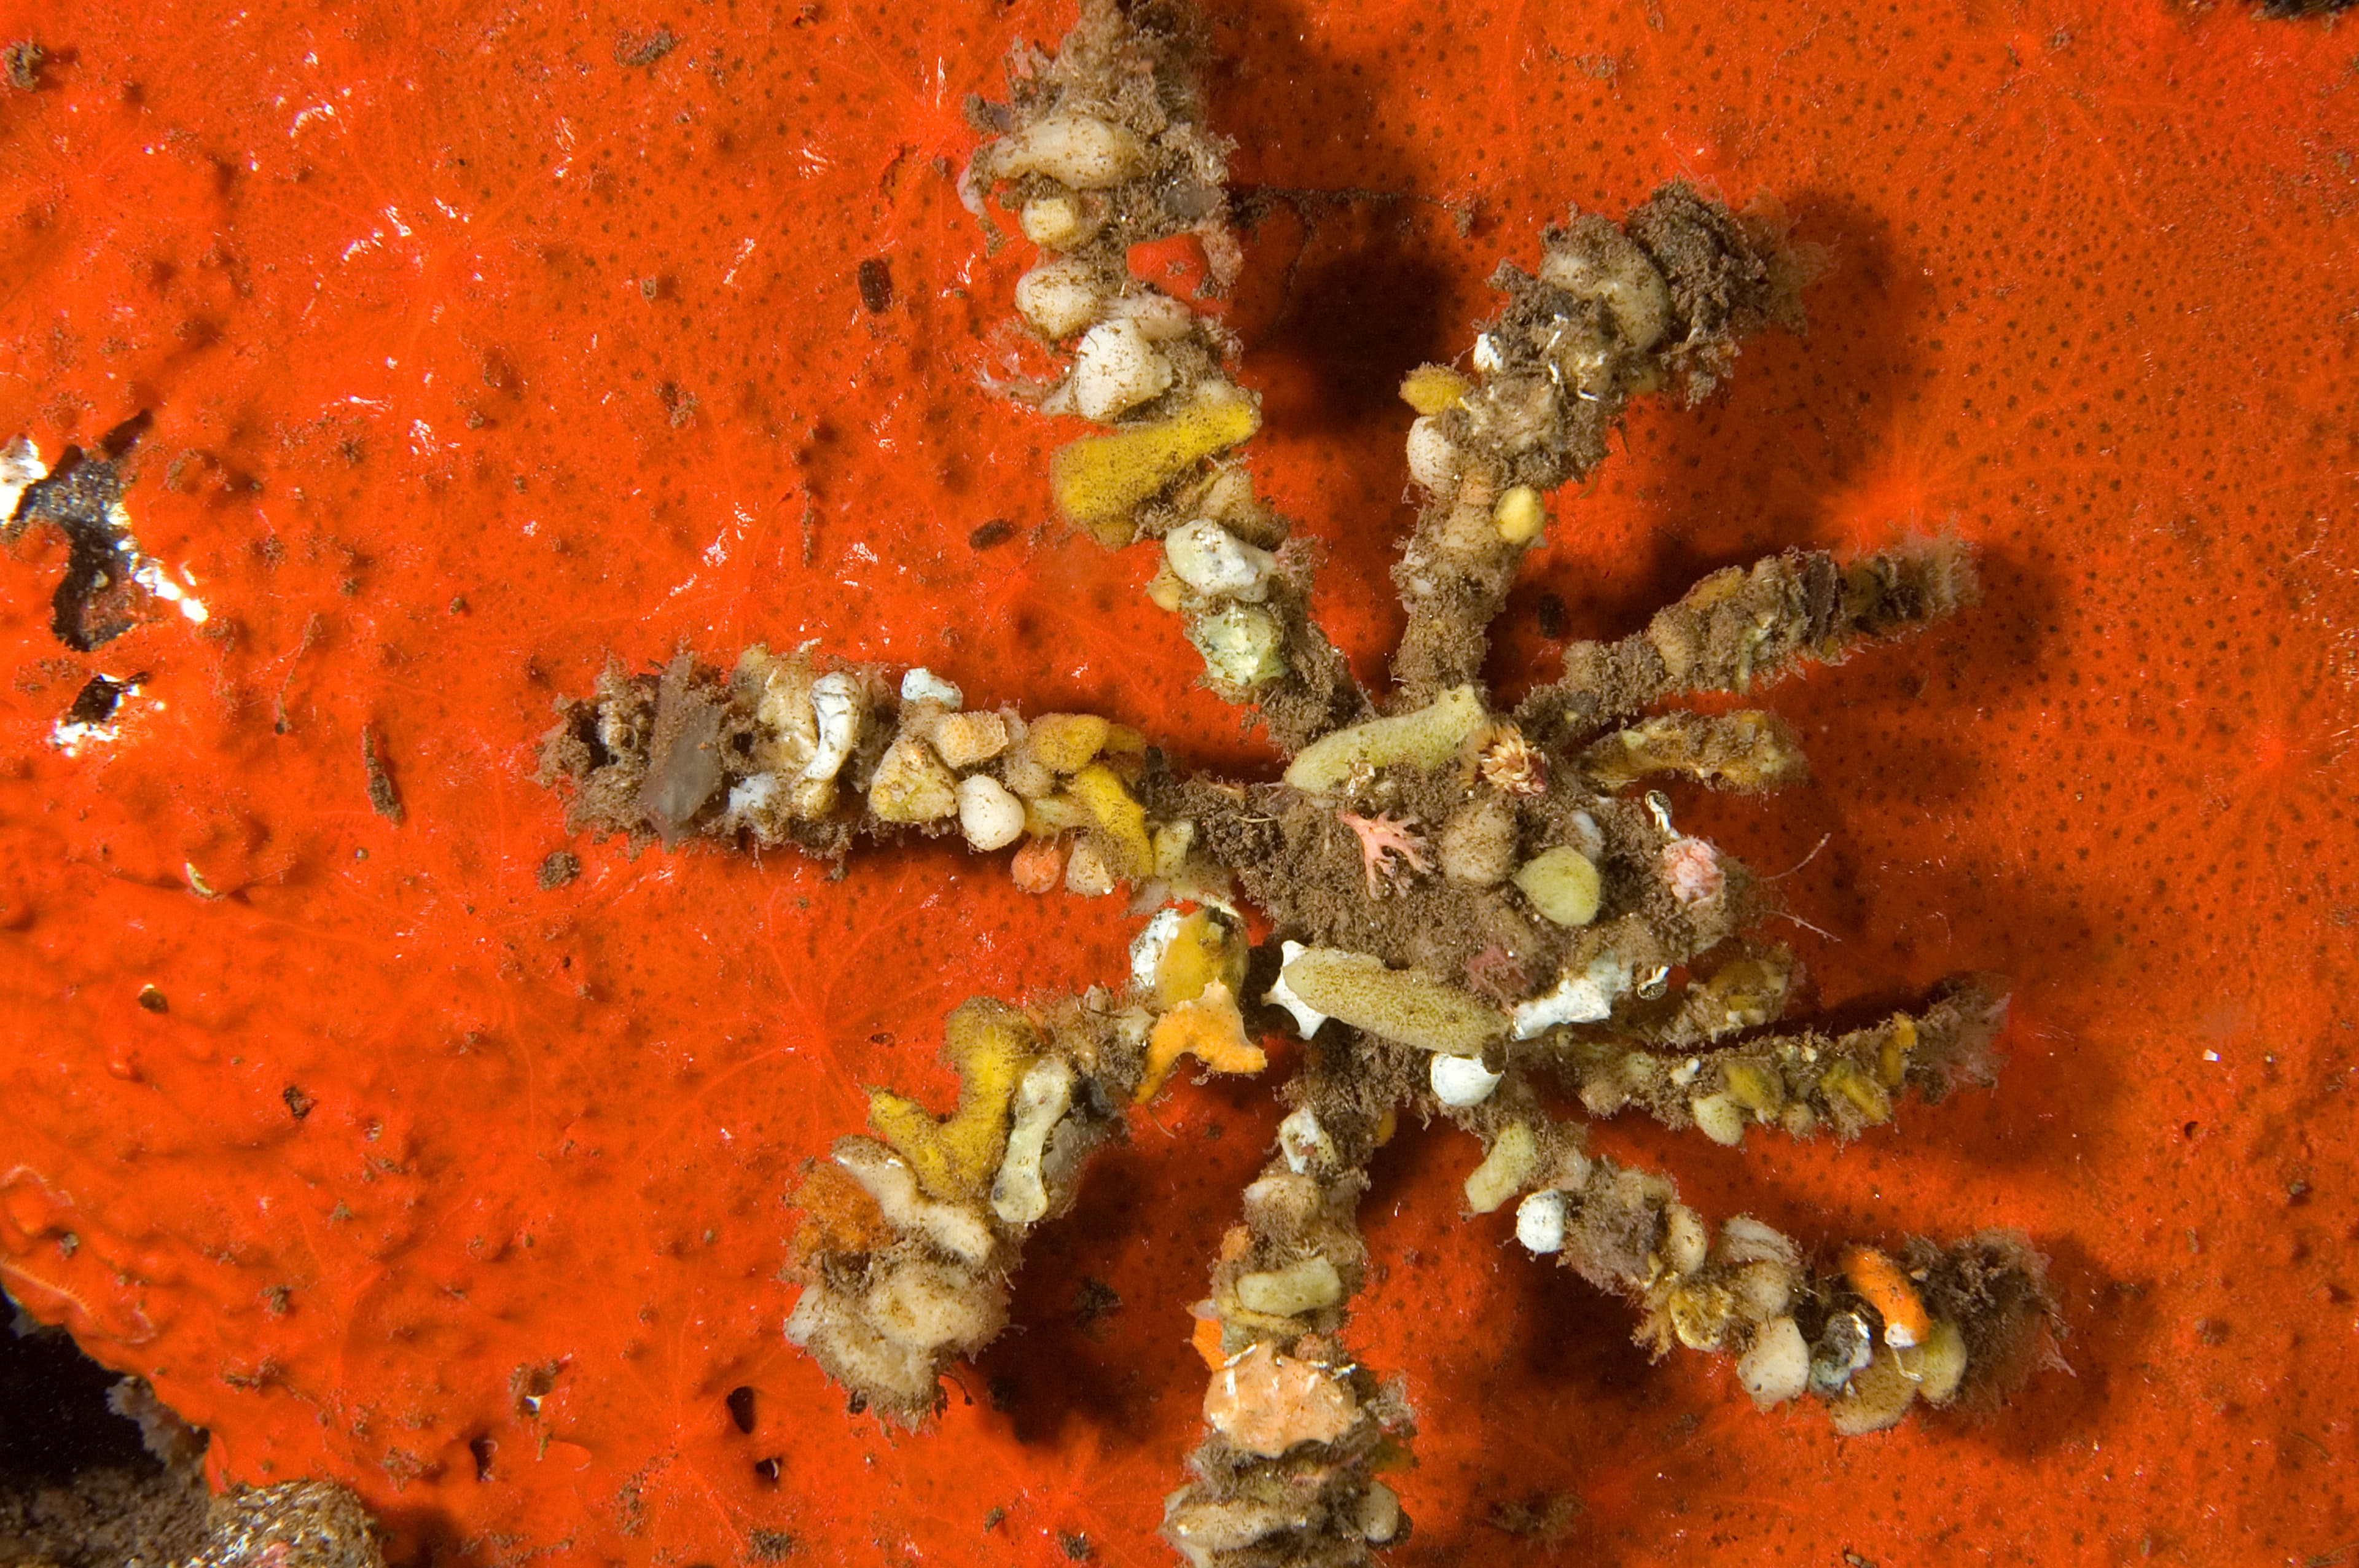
<box><xmin>542</xmin><ymin>0</ymin><xmax>2055</xmax><ymax>1568</ymax></box>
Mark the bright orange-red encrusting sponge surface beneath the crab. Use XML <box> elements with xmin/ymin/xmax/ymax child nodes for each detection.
<box><xmin>0</xmin><ymin>0</ymin><xmax>2359</xmax><ymax>1568</ymax></box>
